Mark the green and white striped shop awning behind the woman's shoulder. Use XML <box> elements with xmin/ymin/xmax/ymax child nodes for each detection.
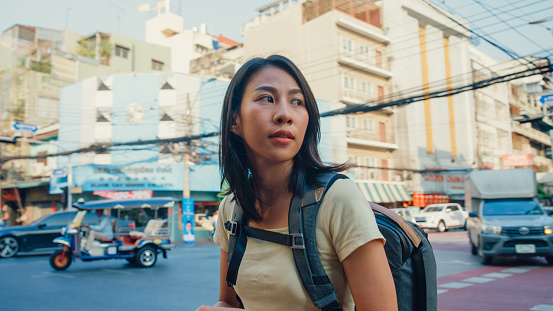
<box><xmin>357</xmin><ymin>181</ymin><xmax>413</xmax><ymax>203</ymax></box>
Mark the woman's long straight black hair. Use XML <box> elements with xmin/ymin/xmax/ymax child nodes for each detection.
<box><xmin>219</xmin><ymin>55</ymin><xmax>348</xmax><ymax>221</ymax></box>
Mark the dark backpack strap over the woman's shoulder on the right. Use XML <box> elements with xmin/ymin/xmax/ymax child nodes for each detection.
<box><xmin>288</xmin><ymin>173</ymin><xmax>347</xmax><ymax>311</ymax></box>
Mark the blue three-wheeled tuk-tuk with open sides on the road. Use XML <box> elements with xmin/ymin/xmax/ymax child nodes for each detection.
<box><xmin>50</xmin><ymin>197</ymin><xmax>175</xmax><ymax>270</ymax></box>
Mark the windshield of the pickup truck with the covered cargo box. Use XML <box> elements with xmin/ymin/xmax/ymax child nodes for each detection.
<box><xmin>482</xmin><ymin>199</ymin><xmax>543</xmax><ymax>216</ymax></box>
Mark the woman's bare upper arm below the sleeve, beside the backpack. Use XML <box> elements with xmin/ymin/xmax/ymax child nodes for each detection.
<box><xmin>342</xmin><ymin>240</ymin><xmax>397</xmax><ymax>311</ymax></box>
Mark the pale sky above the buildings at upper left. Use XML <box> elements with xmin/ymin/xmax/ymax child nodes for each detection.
<box><xmin>0</xmin><ymin>0</ymin><xmax>264</xmax><ymax>42</ymax></box>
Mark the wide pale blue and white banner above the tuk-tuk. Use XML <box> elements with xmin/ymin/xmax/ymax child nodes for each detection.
<box><xmin>73</xmin><ymin>162</ymin><xmax>184</xmax><ymax>191</ymax></box>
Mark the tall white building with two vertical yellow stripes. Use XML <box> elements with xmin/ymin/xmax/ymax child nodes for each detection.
<box><xmin>383</xmin><ymin>0</ymin><xmax>472</xmax><ymax>207</ymax></box>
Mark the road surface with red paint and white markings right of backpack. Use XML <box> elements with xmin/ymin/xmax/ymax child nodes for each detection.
<box><xmin>429</xmin><ymin>231</ymin><xmax>553</xmax><ymax>311</ymax></box>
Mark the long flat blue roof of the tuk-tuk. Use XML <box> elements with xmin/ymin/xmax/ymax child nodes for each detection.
<box><xmin>73</xmin><ymin>197</ymin><xmax>175</xmax><ymax>210</ymax></box>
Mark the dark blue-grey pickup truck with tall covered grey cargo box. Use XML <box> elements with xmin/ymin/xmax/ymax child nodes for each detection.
<box><xmin>465</xmin><ymin>169</ymin><xmax>553</xmax><ymax>265</ymax></box>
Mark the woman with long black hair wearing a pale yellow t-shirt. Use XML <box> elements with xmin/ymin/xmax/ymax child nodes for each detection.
<box><xmin>198</xmin><ymin>55</ymin><xmax>397</xmax><ymax>311</ymax></box>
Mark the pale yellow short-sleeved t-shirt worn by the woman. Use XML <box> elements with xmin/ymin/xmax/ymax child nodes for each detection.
<box><xmin>214</xmin><ymin>179</ymin><xmax>384</xmax><ymax>311</ymax></box>
